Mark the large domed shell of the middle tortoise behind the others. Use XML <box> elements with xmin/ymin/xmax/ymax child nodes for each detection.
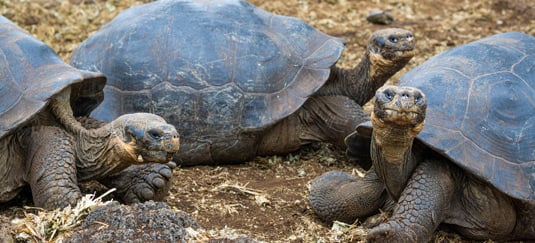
<box><xmin>71</xmin><ymin>0</ymin><xmax>344</xmax><ymax>163</ymax></box>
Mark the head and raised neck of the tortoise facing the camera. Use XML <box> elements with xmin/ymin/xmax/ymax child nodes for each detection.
<box><xmin>370</xmin><ymin>85</ymin><xmax>427</xmax><ymax>200</ymax></box>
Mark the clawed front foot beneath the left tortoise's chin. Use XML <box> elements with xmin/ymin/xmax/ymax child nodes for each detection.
<box><xmin>100</xmin><ymin>162</ymin><xmax>176</xmax><ymax>204</ymax></box>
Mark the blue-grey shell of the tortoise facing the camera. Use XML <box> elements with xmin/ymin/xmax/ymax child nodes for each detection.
<box><xmin>399</xmin><ymin>32</ymin><xmax>535</xmax><ymax>200</ymax></box>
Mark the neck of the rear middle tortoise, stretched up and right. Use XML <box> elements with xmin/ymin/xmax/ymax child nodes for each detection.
<box><xmin>316</xmin><ymin>50</ymin><xmax>410</xmax><ymax>106</ymax></box>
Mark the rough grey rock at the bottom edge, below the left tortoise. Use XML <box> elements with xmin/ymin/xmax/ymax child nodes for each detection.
<box><xmin>63</xmin><ymin>201</ymin><xmax>200</xmax><ymax>242</ymax></box>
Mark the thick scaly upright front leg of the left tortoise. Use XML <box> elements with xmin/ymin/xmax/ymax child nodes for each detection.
<box><xmin>26</xmin><ymin>127</ymin><xmax>82</xmax><ymax>209</ymax></box>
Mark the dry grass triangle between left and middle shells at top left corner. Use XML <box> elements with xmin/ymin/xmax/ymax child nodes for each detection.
<box><xmin>0</xmin><ymin>0</ymin><xmax>150</xmax><ymax>61</ymax></box>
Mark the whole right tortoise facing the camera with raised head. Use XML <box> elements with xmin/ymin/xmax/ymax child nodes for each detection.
<box><xmin>310</xmin><ymin>32</ymin><xmax>535</xmax><ymax>242</ymax></box>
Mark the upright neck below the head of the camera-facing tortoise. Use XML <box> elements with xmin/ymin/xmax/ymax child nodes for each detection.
<box><xmin>371</xmin><ymin>121</ymin><xmax>418</xmax><ymax>200</ymax></box>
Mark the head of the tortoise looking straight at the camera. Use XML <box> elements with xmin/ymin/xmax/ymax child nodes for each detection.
<box><xmin>372</xmin><ymin>85</ymin><xmax>427</xmax><ymax>136</ymax></box>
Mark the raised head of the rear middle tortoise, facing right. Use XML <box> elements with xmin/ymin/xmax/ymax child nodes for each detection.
<box><xmin>367</xmin><ymin>28</ymin><xmax>416</xmax><ymax>62</ymax></box>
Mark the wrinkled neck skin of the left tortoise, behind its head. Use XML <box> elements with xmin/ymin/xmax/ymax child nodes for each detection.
<box><xmin>50</xmin><ymin>88</ymin><xmax>136</xmax><ymax>181</ymax></box>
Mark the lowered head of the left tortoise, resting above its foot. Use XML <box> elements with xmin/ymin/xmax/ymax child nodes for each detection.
<box><xmin>111</xmin><ymin>113</ymin><xmax>180</xmax><ymax>164</ymax></box>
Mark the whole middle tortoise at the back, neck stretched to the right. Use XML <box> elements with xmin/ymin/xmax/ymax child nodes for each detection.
<box><xmin>71</xmin><ymin>0</ymin><xmax>415</xmax><ymax>165</ymax></box>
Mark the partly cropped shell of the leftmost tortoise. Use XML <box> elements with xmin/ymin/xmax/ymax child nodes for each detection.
<box><xmin>0</xmin><ymin>16</ymin><xmax>106</xmax><ymax>138</ymax></box>
